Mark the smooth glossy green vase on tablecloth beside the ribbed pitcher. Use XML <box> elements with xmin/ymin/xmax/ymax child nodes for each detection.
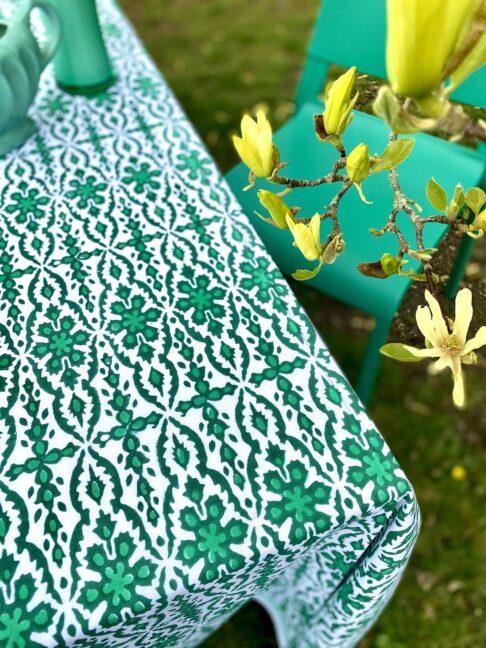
<box><xmin>50</xmin><ymin>0</ymin><xmax>114</xmax><ymax>95</ymax></box>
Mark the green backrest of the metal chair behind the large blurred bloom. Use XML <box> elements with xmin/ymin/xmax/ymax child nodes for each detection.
<box><xmin>296</xmin><ymin>0</ymin><xmax>486</xmax><ymax>107</ymax></box>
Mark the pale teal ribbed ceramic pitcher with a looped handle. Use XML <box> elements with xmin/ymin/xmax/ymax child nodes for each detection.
<box><xmin>0</xmin><ymin>0</ymin><xmax>61</xmax><ymax>156</ymax></box>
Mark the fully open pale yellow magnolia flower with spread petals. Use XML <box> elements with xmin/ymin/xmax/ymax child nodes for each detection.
<box><xmin>381</xmin><ymin>288</ymin><xmax>486</xmax><ymax>407</ymax></box>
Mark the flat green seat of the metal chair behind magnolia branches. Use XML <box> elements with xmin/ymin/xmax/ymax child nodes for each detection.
<box><xmin>227</xmin><ymin>101</ymin><xmax>484</xmax><ymax>319</ymax></box>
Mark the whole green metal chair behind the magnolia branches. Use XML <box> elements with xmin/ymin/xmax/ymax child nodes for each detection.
<box><xmin>227</xmin><ymin>0</ymin><xmax>486</xmax><ymax>402</ymax></box>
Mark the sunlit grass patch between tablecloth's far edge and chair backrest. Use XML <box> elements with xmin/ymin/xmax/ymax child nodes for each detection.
<box><xmin>121</xmin><ymin>0</ymin><xmax>319</xmax><ymax>170</ymax></box>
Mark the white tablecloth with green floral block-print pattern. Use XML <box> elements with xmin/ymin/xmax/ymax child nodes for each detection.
<box><xmin>0</xmin><ymin>0</ymin><xmax>418</xmax><ymax>648</ymax></box>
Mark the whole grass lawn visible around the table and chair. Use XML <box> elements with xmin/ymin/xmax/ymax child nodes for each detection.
<box><xmin>121</xmin><ymin>0</ymin><xmax>486</xmax><ymax>648</ymax></box>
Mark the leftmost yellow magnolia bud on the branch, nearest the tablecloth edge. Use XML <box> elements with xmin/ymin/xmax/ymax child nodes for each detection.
<box><xmin>233</xmin><ymin>110</ymin><xmax>275</xmax><ymax>178</ymax></box>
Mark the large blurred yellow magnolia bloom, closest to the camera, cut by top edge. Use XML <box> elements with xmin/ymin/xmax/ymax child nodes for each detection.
<box><xmin>386</xmin><ymin>0</ymin><xmax>481</xmax><ymax>99</ymax></box>
